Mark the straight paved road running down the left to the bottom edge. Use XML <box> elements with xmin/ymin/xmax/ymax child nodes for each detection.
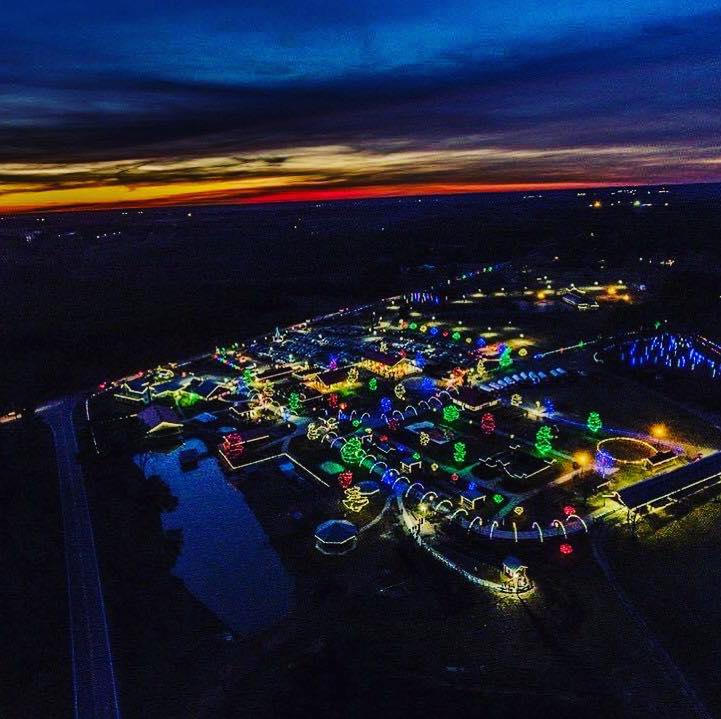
<box><xmin>39</xmin><ymin>397</ymin><xmax>120</xmax><ymax>719</ymax></box>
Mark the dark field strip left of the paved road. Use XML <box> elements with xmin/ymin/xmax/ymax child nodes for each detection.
<box><xmin>0</xmin><ymin>419</ymin><xmax>72</xmax><ymax>719</ymax></box>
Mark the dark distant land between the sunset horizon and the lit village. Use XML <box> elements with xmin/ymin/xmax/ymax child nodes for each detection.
<box><xmin>0</xmin><ymin>185</ymin><xmax>721</xmax><ymax>407</ymax></box>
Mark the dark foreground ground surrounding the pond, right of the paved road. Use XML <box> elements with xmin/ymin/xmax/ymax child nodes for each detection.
<box><xmin>79</xmin><ymin>430</ymin><xmax>704</xmax><ymax>719</ymax></box>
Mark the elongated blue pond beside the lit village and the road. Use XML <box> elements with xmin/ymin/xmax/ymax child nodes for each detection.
<box><xmin>137</xmin><ymin>439</ymin><xmax>295</xmax><ymax>636</ymax></box>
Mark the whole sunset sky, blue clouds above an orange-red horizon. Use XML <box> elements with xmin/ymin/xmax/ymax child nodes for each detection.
<box><xmin>0</xmin><ymin>0</ymin><xmax>721</xmax><ymax>211</ymax></box>
